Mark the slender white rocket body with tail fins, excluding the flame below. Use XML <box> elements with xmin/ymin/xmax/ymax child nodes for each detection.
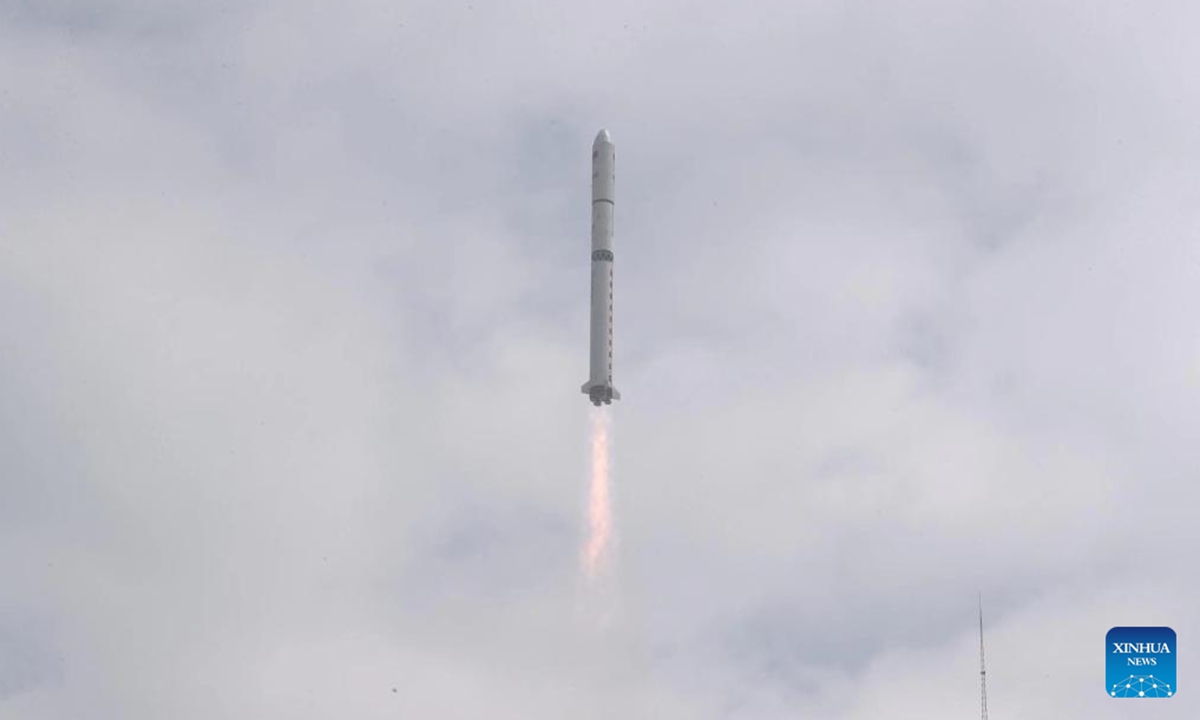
<box><xmin>580</xmin><ymin>130</ymin><xmax>620</xmax><ymax>407</ymax></box>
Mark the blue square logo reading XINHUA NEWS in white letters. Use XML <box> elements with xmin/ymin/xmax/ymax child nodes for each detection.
<box><xmin>1104</xmin><ymin>628</ymin><xmax>1176</xmax><ymax>697</ymax></box>
